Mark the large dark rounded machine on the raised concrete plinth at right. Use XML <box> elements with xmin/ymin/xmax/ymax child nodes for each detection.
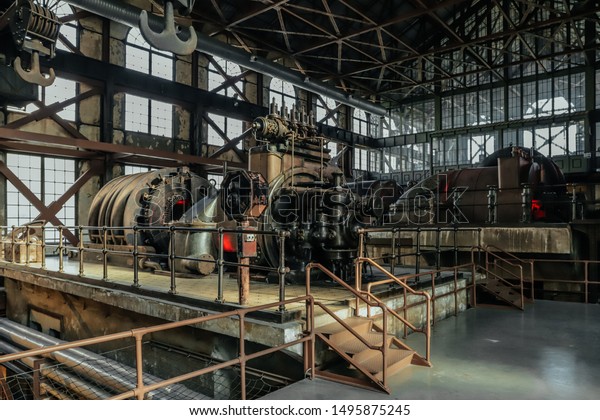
<box><xmin>391</xmin><ymin>147</ymin><xmax>572</xmax><ymax>226</ymax></box>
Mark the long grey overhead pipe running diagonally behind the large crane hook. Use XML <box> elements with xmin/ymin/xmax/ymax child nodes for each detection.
<box><xmin>65</xmin><ymin>0</ymin><xmax>387</xmax><ymax>117</ymax></box>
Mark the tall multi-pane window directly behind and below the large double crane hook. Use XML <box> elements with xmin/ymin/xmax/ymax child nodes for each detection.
<box><xmin>125</xmin><ymin>28</ymin><xmax>173</xmax><ymax>137</ymax></box>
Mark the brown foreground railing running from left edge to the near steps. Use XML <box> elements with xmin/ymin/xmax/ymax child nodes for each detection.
<box><xmin>0</xmin><ymin>295</ymin><xmax>314</xmax><ymax>400</ymax></box>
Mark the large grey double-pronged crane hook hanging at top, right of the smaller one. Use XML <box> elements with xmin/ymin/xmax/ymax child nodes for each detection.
<box><xmin>140</xmin><ymin>1</ymin><xmax>198</xmax><ymax>55</ymax></box>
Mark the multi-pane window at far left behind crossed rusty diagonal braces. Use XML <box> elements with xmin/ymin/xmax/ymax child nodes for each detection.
<box><xmin>6</xmin><ymin>153</ymin><xmax>76</xmax><ymax>233</ymax></box>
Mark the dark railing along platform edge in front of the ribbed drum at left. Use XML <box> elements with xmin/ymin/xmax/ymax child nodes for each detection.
<box><xmin>0</xmin><ymin>224</ymin><xmax>289</xmax><ymax>311</ymax></box>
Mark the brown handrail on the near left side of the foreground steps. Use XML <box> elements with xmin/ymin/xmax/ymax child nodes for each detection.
<box><xmin>306</xmin><ymin>262</ymin><xmax>390</xmax><ymax>393</ymax></box>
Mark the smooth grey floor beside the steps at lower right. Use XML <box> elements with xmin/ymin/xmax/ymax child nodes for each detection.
<box><xmin>267</xmin><ymin>301</ymin><xmax>600</xmax><ymax>400</ymax></box>
